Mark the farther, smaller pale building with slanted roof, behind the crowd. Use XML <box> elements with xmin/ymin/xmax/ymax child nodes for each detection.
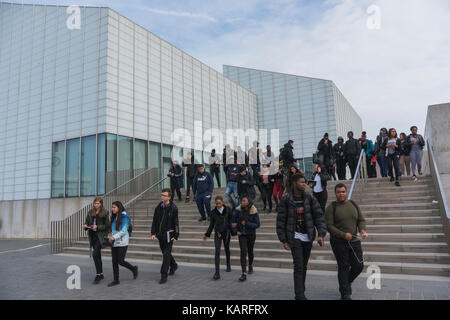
<box><xmin>223</xmin><ymin>65</ymin><xmax>362</xmax><ymax>173</ymax></box>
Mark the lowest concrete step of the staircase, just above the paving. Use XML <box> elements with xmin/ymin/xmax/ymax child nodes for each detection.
<box><xmin>64</xmin><ymin>247</ymin><xmax>450</xmax><ymax>276</ymax></box>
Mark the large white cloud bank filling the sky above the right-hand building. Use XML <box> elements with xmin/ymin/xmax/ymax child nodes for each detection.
<box><xmin>182</xmin><ymin>0</ymin><xmax>450</xmax><ymax>138</ymax></box>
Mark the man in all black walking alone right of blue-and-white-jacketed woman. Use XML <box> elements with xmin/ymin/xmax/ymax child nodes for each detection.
<box><xmin>151</xmin><ymin>188</ymin><xmax>180</xmax><ymax>284</ymax></box>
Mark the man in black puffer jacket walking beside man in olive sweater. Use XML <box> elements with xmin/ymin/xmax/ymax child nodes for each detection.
<box><xmin>277</xmin><ymin>174</ymin><xmax>327</xmax><ymax>300</ymax></box>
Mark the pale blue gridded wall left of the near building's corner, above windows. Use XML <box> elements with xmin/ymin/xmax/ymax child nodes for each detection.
<box><xmin>0</xmin><ymin>3</ymin><xmax>107</xmax><ymax>200</ymax></box>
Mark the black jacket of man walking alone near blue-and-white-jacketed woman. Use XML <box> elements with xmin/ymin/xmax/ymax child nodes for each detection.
<box><xmin>151</xmin><ymin>201</ymin><xmax>180</xmax><ymax>241</ymax></box>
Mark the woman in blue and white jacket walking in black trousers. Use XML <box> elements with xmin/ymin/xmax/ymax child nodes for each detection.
<box><xmin>108</xmin><ymin>201</ymin><xmax>138</xmax><ymax>287</ymax></box>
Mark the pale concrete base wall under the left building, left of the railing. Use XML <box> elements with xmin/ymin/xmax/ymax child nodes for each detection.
<box><xmin>0</xmin><ymin>197</ymin><xmax>94</xmax><ymax>239</ymax></box>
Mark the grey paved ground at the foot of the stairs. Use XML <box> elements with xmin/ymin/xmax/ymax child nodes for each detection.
<box><xmin>0</xmin><ymin>240</ymin><xmax>450</xmax><ymax>300</ymax></box>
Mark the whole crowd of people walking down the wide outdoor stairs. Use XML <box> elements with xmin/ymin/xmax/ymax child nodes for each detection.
<box><xmin>83</xmin><ymin>126</ymin><xmax>425</xmax><ymax>300</ymax></box>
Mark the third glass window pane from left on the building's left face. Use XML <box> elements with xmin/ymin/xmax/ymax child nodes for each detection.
<box><xmin>80</xmin><ymin>136</ymin><xmax>96</xmax><ymax>196</ymax></box>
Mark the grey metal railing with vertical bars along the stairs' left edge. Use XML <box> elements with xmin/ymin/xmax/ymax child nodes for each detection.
<box><xmin>50</xmin><ymin>168</ymin><xmax>168</xmax><ymax>254</ymax></box>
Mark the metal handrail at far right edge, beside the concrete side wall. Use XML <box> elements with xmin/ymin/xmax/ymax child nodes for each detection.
<box><xmin>427</xmin><ymin>139</ymin><xmax>450</xmax><ymax>254</ymax></box>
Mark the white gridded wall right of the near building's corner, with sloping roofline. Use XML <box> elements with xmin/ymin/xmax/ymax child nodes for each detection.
<box><xmin>106</xmin><ymin>9</ymin><xmax>258</xmax><ymax>147</ymax></box>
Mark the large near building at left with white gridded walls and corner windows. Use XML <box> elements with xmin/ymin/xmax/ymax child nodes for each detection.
<box><xmin>0</xmin><ymin>3</ymin><xmax>258</xmax><ymax>200</ymax></box>
